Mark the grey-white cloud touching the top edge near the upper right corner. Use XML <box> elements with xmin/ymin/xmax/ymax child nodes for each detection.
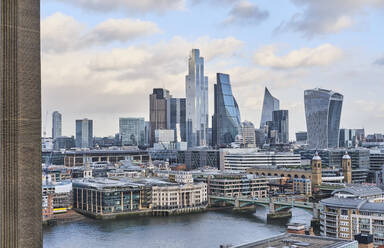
<box><xmin>275</xmin><ymin>0</ymin><xmax>384</xmax><ymax>38</ymax></box>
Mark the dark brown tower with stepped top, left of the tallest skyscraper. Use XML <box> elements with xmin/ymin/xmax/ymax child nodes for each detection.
<box><xmin>149</xmin><ymin>89</ymin><xmax>171</xmax><ymax>146</ymax></box>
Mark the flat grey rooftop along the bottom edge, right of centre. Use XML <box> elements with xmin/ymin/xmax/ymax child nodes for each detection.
<box><xmin>228</xmin><ymin>233</ymin><xmax>358</xmax><ymax>248</ymax></box>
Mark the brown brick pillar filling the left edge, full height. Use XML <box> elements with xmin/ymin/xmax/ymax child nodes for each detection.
<box><xmin>0</xmin><ymin>0</ymin><xmax>42</xmax><ymax>248</ymax></box>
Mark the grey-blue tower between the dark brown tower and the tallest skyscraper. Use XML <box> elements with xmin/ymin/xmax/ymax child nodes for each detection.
<box><xmin>168</xmin><ymin>98</ymin><xmax>187</xmax><ymax>142</ymax></box>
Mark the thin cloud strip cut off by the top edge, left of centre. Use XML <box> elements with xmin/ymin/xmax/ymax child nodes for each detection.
<box><xmin>46</xmin><ymin>0</ymin><xmax>185</xmax><ymax>14</ymax></box>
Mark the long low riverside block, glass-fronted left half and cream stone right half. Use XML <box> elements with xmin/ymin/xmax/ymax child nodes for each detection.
<box><xmin>73</xmin><ymin>178</ymin><xmax>208</xmax><ymax>218</ymax></box>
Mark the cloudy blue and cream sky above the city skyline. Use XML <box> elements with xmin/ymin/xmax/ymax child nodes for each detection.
<box><xmin>42</xmin><ymin>0</ymin><xmax>384</xmax><ymax>137</ymax></box>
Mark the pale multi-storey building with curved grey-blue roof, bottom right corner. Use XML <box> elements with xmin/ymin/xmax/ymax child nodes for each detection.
<box><xmin>320</xmin><ymin>185</ymin><xmax>384</xmax><ymax>246</ymax></box>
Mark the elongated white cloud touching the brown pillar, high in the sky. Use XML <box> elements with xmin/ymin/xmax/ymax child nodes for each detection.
<box><xmin>41</xmin><ymin>13</ymin><xmax>160</xmax><ymax>52</ymax></box>
